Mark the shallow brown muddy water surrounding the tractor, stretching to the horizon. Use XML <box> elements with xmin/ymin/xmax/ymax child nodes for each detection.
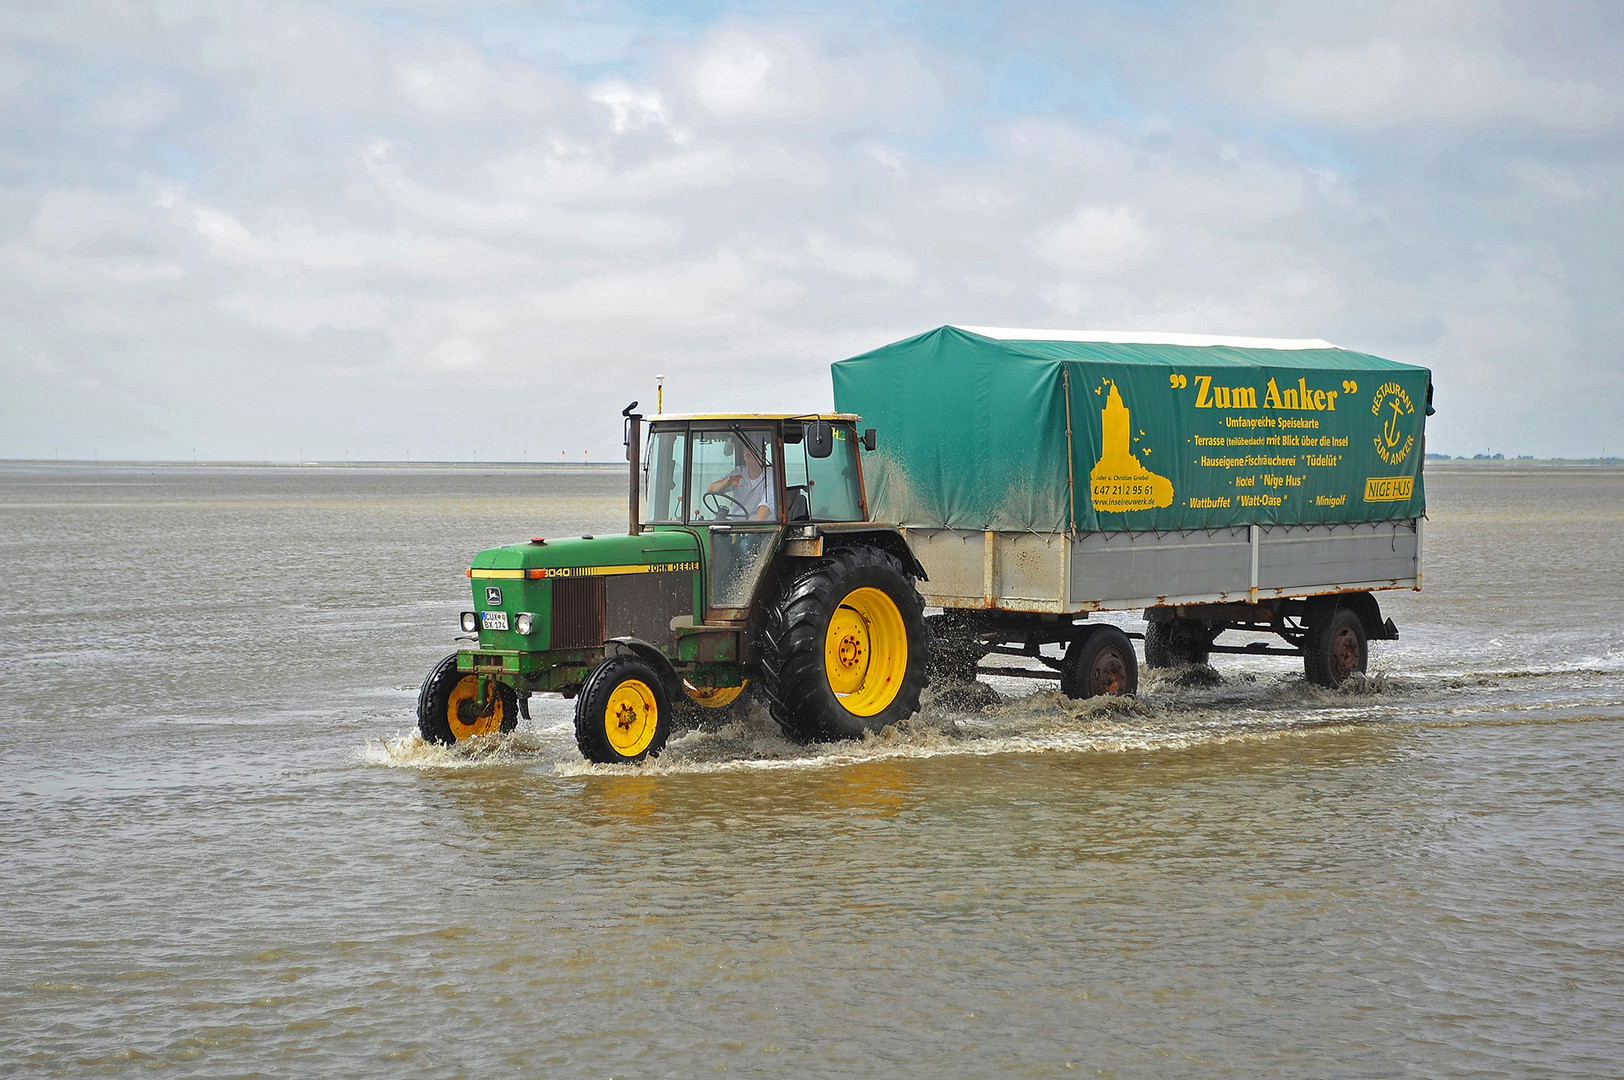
<box><xmin>0</xmin><ymin>464</ymin><xmax>1624</xmax><ymax>1078</ymax></box>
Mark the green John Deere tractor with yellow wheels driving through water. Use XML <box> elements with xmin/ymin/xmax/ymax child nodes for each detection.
<box><xmin>417</xmin><ymin>409</ymin><xmax>929</xmax><ymax>763</ymax></box>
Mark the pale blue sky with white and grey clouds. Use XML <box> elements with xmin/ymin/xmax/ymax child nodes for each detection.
<box><xmin>0</xmin><ymin>0</ymin><xmax>1624</xmax><ymax>461</ymax></box>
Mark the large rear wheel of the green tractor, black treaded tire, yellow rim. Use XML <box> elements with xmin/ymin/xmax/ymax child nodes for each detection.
<box><xmin>760</xmin><ymin>547</ymin><xmax>931</xmax><ymax>742</ymax></box>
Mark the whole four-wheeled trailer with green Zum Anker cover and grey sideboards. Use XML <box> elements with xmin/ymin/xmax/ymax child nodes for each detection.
<box><xmin>833</xmin><ymin>319</ymin><xmax>1431</xmax><ymax>697</ymax></box>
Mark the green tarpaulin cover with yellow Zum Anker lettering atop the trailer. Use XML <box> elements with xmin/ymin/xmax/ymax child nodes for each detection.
<box><xmin>833</xmin><ymin>326</ymin><xmax>1431</xmax><ymax>533</ymax></box>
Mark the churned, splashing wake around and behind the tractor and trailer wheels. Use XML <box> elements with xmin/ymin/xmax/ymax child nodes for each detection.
<box><xmin>361</xmin><ymin>652</ymin><xmax>1624</xmax><ymax>776</ymax></box>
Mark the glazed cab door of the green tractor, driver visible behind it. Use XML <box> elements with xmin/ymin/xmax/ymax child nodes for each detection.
<box><xmin>689</xmin><ymin>422</ymin><xmax>783</xmax><ymax>622</ymax></box>
